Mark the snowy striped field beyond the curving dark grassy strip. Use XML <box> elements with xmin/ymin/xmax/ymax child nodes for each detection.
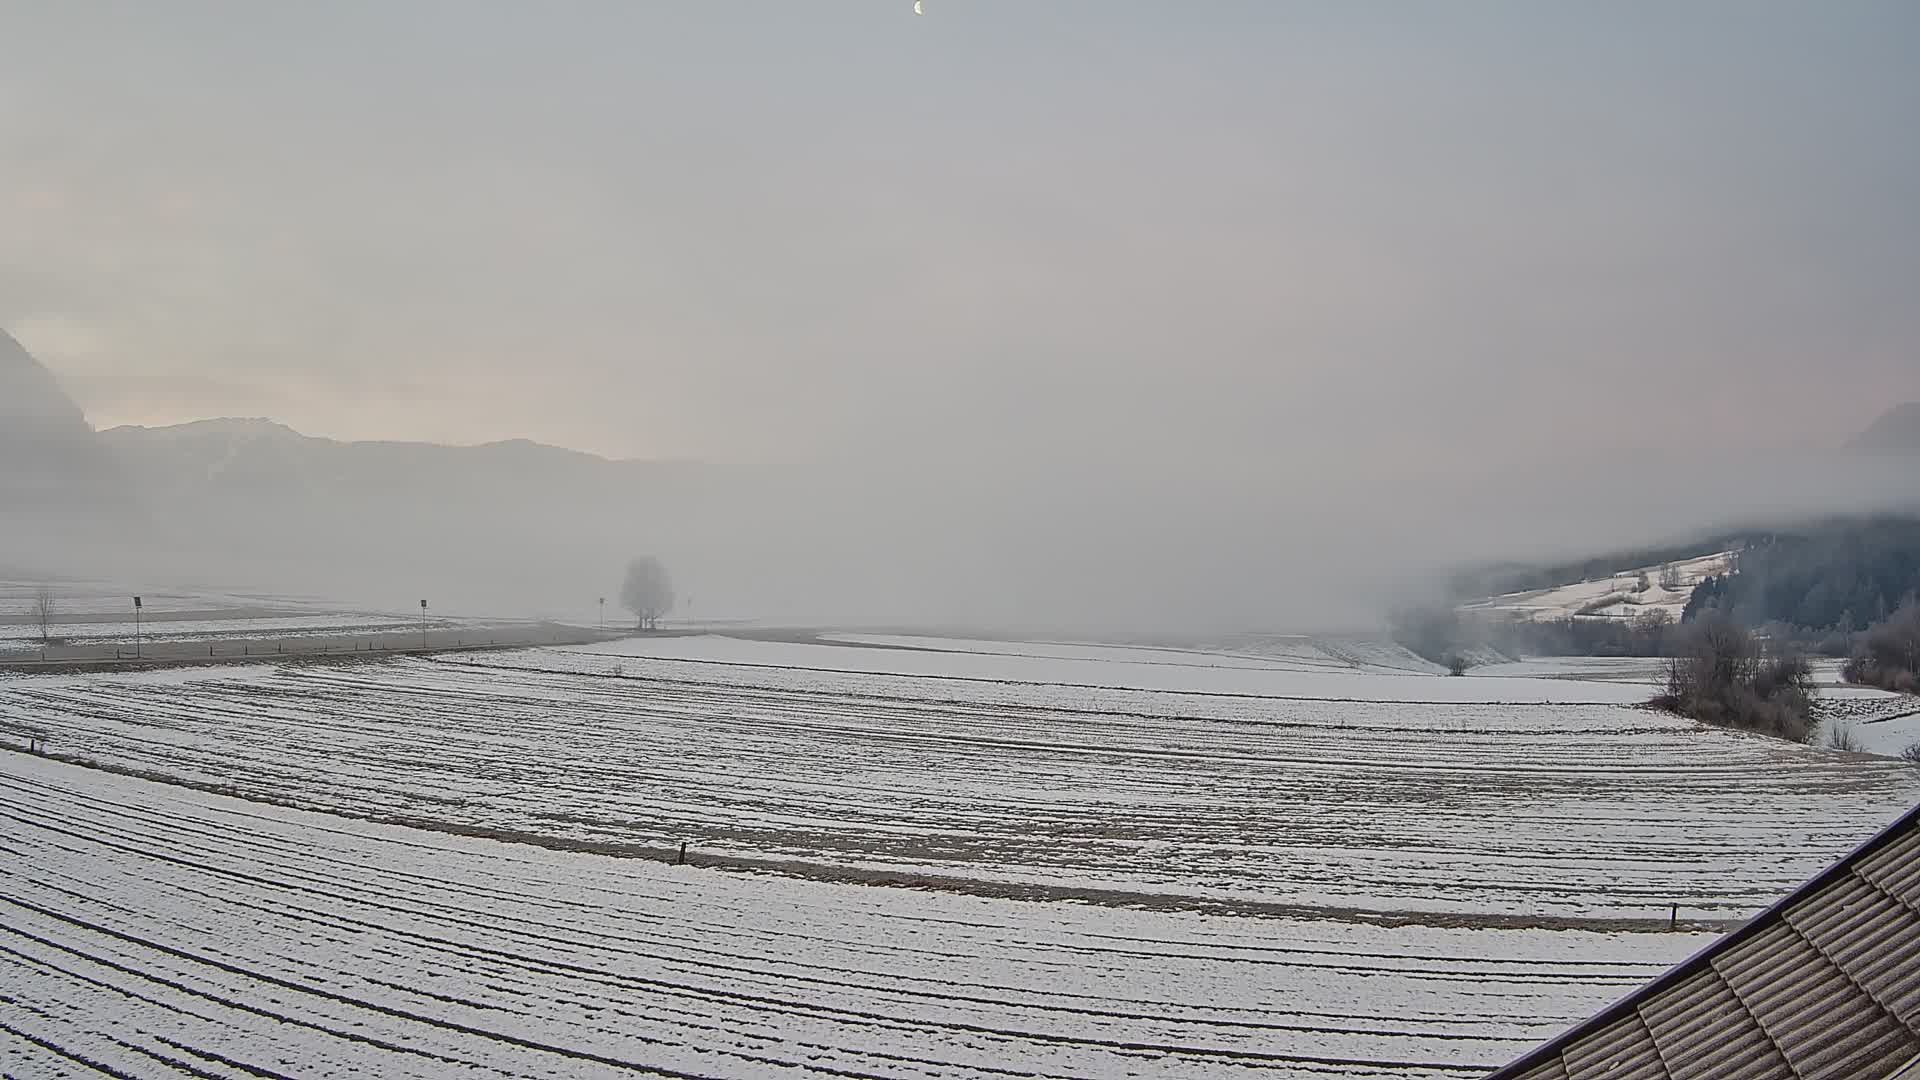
<box><xmin>0</xmin><ymin>638</ymin><xmax>1920</xmax><ymax>919</ymax></box>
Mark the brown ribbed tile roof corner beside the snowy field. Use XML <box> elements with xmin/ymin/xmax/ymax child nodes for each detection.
<box><xmin>1488</xmin><ymin>807</ymin><xmax>1920</xmax><ymax>1080</ymax></box>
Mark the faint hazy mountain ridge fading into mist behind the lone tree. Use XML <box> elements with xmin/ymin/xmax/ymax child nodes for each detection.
<box><xmin>84</xmin><ymin>419</ymin><xmax>768</xmax><ymax>611</ymax></box>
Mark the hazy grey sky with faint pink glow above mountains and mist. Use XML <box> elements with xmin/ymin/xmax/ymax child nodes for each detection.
<box><xmin>0</xmin><ymin>0</ymin><xmax>1920</xmax><ymax>467</ymax></box>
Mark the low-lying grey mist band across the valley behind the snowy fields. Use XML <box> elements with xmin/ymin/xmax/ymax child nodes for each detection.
<box><xmin>0</xmin><ymin>403</ymin><xmax>1920</xmax><ymax>634</ymax></box>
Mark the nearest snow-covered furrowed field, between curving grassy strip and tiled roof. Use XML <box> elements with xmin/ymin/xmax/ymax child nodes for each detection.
<box><xmin>0</xmin><ymin>751</ymin><xmax>1711</xmax><ymax>1080</ymax></box>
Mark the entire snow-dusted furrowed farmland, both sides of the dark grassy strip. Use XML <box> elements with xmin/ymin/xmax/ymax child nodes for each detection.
<box><xmin>0</xmin><ymin>636</ymin><xmax>1920</xmax><ymax>1078</ymax></box>
